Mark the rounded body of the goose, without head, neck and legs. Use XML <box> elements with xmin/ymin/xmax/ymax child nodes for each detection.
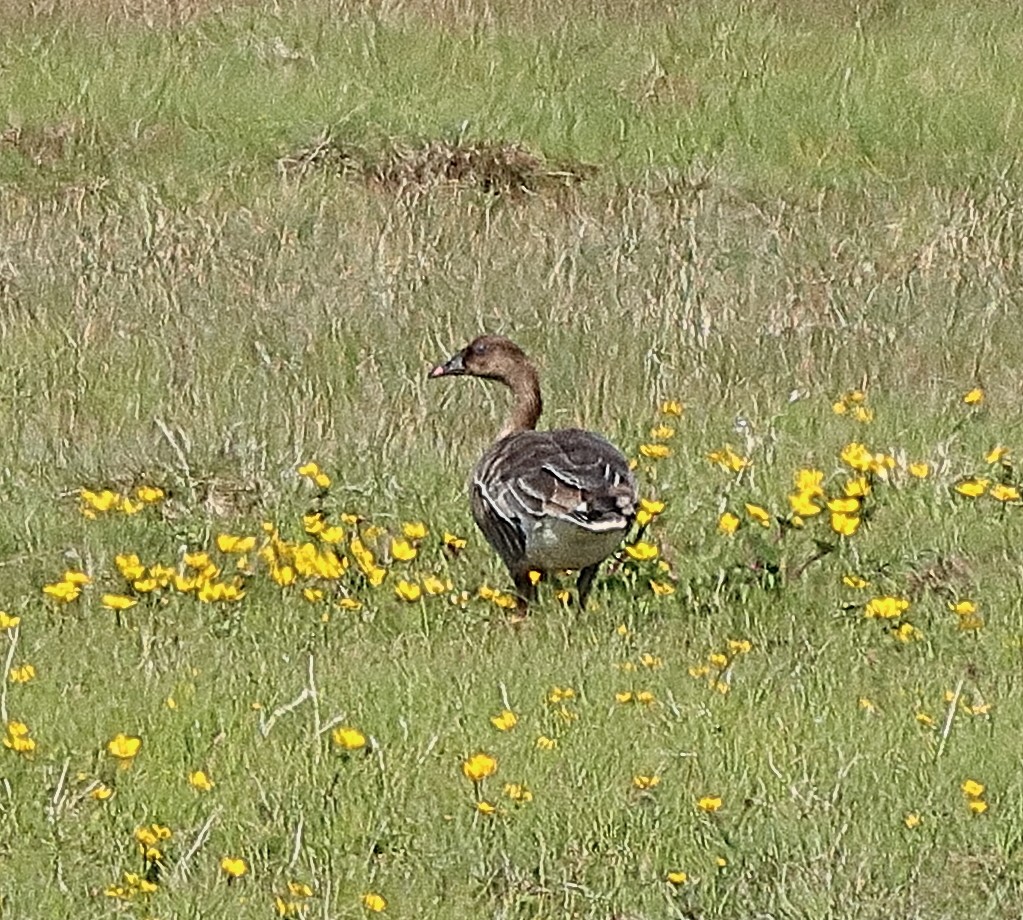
<box><xmin>471</xmin><ymin>429</ymin><xmax>638</xmax><ymax>573</ymax></box>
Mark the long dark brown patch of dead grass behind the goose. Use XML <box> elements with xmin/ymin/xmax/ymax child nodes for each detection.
<box><xmin>277</xmin><ymin>132</ymin><xmax>596</xmax><ymax>194</ymax></box>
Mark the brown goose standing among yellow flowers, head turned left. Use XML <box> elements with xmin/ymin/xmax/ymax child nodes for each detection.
<box><xmin>430</xmin><ymin>336</ymin><xmax>638</xmax><ymax>613</ymax></box>
